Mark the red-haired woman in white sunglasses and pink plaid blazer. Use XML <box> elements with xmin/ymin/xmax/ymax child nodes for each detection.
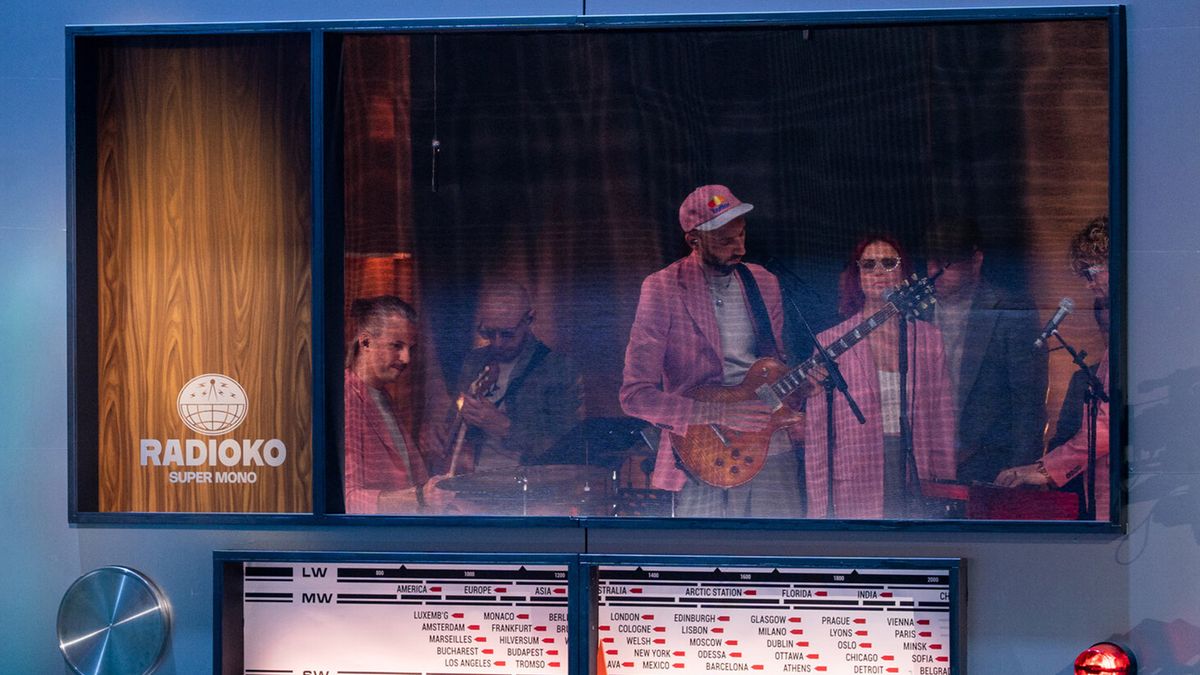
<box><xmin>805</xmin><ymin>235</ymin><xmax>955</xmax><ymax>519</ymax></box>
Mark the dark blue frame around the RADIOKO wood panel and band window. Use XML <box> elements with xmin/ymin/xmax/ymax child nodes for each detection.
<box><xmin>66</xmin><ymin>5</ymin><xmax>1128</xmax><ymax>534</ymax></box>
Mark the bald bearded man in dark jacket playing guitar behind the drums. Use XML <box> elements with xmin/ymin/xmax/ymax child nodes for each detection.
<box><xmin>443</xmin><ymin>281</ymin><xmax>583</xmax><ymax>474</ymax></box>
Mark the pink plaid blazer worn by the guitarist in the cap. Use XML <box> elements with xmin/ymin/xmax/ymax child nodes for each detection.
<box><xmin>620</xmin><ymin>253</ymin><xmax>784</xmax><ymax>491</ymax></box>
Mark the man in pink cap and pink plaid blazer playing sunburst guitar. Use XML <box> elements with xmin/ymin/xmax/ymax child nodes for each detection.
<box><xmin>620</xmin><ymin>185</ymin><xmax>809</xmax><ymax>518</ymax></box>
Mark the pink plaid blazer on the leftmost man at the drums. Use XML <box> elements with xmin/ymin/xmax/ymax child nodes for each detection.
<box><xmin>343</xmin><ymin>370</ymin><xmax>428</xmax><ymax>513</ymax></box>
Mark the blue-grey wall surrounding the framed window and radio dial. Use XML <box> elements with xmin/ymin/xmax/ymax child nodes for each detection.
<box><xmin>0</xmin><ymin>0</ymin><xmax>1200</xmax><ymax>675</ymax></box>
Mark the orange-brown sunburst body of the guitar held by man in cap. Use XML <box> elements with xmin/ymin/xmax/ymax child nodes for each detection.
<box><xmin>671</xmin><ymin>358</ymin><xmax>804</xmax><ymax>488</ymax></box>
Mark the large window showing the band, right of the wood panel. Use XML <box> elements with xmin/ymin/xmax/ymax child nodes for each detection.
<box><xmin>326</xmin><ymin>11</ymin><xmax>1121</xmax><ymax>522</ymax></box>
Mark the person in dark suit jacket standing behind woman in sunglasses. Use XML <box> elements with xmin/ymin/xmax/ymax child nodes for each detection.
<box><xmin>925</xmin><ymin>221</ymin><xmax>1046</xmax><ymax>482</ymax></box>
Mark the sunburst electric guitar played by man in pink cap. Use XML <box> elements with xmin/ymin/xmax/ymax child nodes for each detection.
<box><xmin>671</xmin><ymin>274</ymin><xmax>936</xmax><ymax>488</ymax></box>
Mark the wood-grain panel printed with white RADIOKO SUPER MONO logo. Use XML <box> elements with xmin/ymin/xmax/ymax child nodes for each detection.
<box><xmin>96</xmin><ymin>36</ymin><xmax>312</xmax><ymax>513</ymax></box>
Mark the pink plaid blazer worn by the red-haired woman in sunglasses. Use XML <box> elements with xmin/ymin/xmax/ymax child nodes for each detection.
<box><xmin>804</xmin><ymin>312</ymin><xmax>955</xmax><ymax>518</ymax></box>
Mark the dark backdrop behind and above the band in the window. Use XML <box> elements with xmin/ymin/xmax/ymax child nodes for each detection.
<box><xmin>343</xmin><ymin>22</ymin><xmax>1106</xmax><ymax>441</ymax></box>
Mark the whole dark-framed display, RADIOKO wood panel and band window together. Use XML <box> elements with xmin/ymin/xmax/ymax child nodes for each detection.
<box><xmin>67</xmin><ymin>7</ymin><xmax>1126</xmax><ymax>531</ymax></box>
